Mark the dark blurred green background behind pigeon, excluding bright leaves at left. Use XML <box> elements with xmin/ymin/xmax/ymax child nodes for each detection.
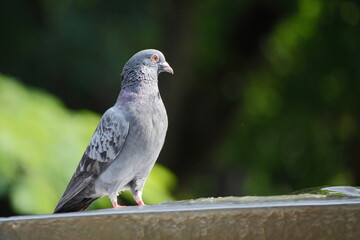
<box><xmin>0</xmin><ymin>0</ymin><xmax>360</xmax><ymax>215</ymax></box>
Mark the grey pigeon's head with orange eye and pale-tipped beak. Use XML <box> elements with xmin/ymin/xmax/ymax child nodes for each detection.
<box><xmin>124</xmin><ymin>49</ymin><xmax>174</xmax><ymax>74</ymax></box>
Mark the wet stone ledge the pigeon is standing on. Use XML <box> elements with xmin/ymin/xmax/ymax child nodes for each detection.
<box><xmin>0</xmin><ymin>195</ymin><xmax>360</xmax><ymax>240</ymax></box>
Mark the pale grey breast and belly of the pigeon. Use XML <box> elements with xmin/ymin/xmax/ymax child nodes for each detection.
<box><xmin>97</xmin><ymin>94</ymin><xmax>168</xmax><ymax>193</ymax></box>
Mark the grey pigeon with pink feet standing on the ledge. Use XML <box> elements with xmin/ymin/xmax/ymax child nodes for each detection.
<box><xmin>54</xmin><ymin>49</ymin><xmax>174</xmax><ymax>213</ymax></box>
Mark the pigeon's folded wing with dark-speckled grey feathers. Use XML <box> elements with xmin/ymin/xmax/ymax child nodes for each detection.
<box><xmin>56</xmin><ymin>107</ymin><xmax>129</xmax><ymax>209</ymax></box>
